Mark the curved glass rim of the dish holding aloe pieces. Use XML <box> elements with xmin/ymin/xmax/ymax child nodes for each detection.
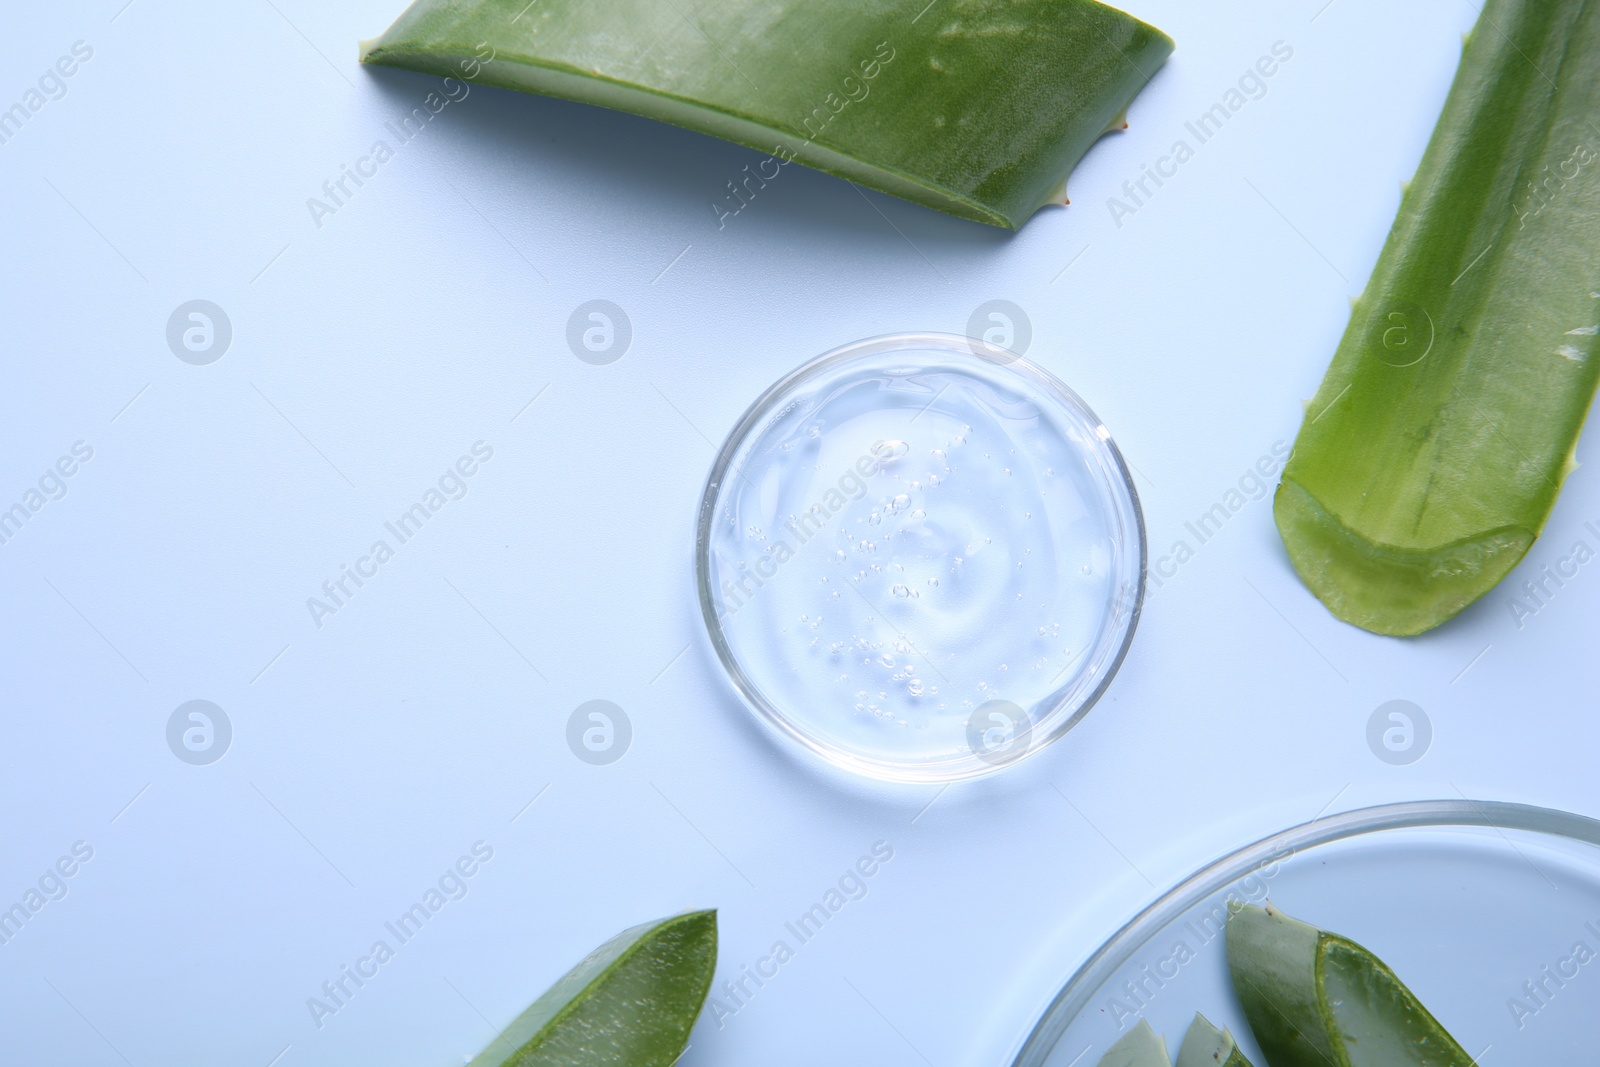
<box><xmin>1011</xmin><ymin>800</ymin><xmax>1600</xmax><ymax>1067</ymax></box>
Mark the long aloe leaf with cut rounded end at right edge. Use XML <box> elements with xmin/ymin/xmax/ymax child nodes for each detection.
<box><xmin>1274</xmin><ymin>0</ymin><xmax>1600</xmax><ymax>635</ymax></box>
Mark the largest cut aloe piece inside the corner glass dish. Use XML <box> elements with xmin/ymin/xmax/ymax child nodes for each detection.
<box><xmin>1227</xmin><ymin>905</ymin><xmax>1472</xmax><ymax>1067</ymax></box>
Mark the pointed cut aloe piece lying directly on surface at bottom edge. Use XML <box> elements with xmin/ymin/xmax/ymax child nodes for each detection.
<box><xmin>469</xmin><ymin>912</ymin><xmax>717</xmax><ymax>1067</ymax></box>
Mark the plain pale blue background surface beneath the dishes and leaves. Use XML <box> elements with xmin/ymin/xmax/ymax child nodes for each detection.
<box><xmin>0</xmin><ymin>0</ymin><xmax>1600</xmax><ymax>1067</ymax></box>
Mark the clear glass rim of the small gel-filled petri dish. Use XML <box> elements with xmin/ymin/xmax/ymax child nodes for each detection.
<box><xmin>694</xmin><ymin>333</ymin><xmax>1149</xmax><ymax>782</ymax></box>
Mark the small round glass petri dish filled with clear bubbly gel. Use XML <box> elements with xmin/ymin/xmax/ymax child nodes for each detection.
<box><xmin>696</xmin><ymin>334</ymin><xmax>1146</xmax><ymax>782</ymax></box>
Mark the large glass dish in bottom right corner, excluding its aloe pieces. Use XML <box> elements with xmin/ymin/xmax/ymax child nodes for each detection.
<box><xmin>1011</xmin><ymin>800</ymin><xmax>1600</xmax><ymax>1067</ymax></box>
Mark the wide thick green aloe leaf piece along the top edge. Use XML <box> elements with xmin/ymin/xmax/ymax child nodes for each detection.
<box><xmin>362</xmin><ymin>0</ymin><xmax>1173</xmax><ymax>229</ymax></box>
